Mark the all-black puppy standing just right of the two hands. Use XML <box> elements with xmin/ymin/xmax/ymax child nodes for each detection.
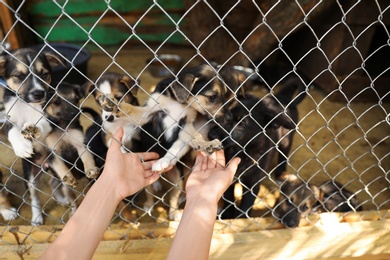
<box><xmin>209</xmin><ymin>76</ymin><xmax>302</xmax><ymax>218</ymax></box>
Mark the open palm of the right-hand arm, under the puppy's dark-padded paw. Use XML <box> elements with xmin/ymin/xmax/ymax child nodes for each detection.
<box><xmin>186</xmin><ymin>150</ymin><xmax>241</xmax><ymax>203</ymax></box>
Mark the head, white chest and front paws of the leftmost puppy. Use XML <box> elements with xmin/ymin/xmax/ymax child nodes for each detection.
<box><xmin>0</xmin><ymin>48</ymin><xmax>64</xmax><ymax>158</ymax></box>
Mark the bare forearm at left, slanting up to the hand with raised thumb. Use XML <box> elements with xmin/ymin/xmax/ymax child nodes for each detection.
<box><xmin>41</xmin><ymin>173</ymin><xmax>120</xmax><ymax>260</ymax></box>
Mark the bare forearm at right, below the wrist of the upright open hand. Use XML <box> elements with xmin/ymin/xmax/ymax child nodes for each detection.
<box><xmin>168</xmin><ymin>200</ymin><xmax>217</xmax><ymax>260</ymax></box>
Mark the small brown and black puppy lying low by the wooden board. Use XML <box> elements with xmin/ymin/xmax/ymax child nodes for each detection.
<box><xmin>274</xmin><ymin>172</ymin><xmax>362</xmax><ymax>228</ymax></box>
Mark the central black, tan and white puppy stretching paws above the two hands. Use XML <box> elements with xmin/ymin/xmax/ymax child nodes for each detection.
<box><xmin>85</xmin><ymin>65</ymin><xmax>244</xmax><ymax>219</ymax></box>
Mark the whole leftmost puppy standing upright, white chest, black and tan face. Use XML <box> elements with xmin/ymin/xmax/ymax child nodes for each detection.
<box><xmin>0</xmin><ymin>48</ymin><xmax>64</xmax><ymax>224</ymax></box>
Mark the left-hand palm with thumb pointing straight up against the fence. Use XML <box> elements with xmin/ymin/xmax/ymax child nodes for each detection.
<box><xmin>100</xmin><ymin>127</ymin><xmax>160</xmax><ymax>200</ymax></box>
